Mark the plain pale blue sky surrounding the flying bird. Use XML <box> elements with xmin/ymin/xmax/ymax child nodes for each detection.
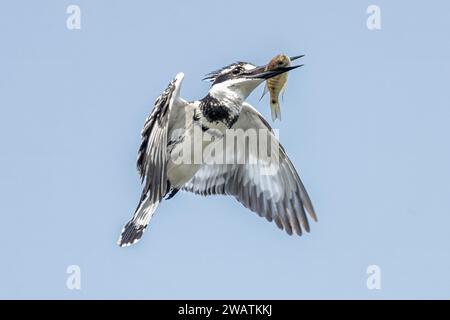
<box><xmin>0</xmin><ymin>0</ymin><xmax>450</xmax><ymax>299</ymax></box>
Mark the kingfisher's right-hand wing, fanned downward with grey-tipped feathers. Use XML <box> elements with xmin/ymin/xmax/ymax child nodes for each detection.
<box><xmin>183</xmin><ymin>103</ymin><xmax>317</xmax><ymax>235</ymax></box>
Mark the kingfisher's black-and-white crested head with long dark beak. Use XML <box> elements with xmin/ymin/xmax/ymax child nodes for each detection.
<box><xmin>204</xmin><ymin>56</ymin><xmax>301</xmax><ymax>101</ymax></box>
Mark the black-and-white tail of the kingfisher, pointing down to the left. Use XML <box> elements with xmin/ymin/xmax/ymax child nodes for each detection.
<box><xmin>117</xmin><ymin>197</ymin><xmax>159</xmax><ymax>247</ymax></box>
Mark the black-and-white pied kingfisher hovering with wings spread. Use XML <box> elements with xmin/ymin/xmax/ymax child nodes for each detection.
<box><xmin>118</xmin><ymin>56</ymin><xmax>317</xmax><ymax>246</ymax></box>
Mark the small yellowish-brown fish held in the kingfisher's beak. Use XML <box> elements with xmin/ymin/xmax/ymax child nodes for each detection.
<box><xmin>260</xmin><ymin>54</ymin><xmax>291</xmax><ymax>121</ymax></box>
